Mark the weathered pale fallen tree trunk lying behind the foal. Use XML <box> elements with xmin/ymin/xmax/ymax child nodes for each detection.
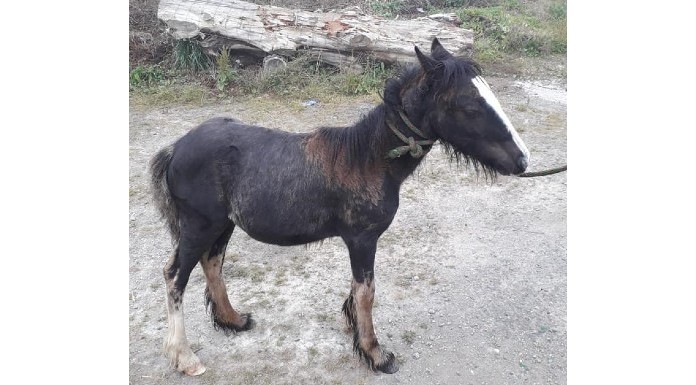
<box><xmin>157</xmin><ymin>0</ymin><xmax>473</xmax><ymax>67</ymax></box>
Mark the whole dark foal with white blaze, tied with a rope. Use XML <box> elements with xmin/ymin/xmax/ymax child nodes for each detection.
<box><xmin>149</xmin><ymin>38</ymin><xmax>529</xmax><ymax>376</ymax></box>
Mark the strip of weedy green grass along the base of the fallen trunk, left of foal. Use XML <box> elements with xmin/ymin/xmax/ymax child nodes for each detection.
<box><xmin>129</xmin><ymin>40</ymin><xmax>396</xmax><ymax>101</ymax></box>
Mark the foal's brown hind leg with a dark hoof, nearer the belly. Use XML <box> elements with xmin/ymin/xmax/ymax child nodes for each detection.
<box><xmin>201</xmin><ymin>223</ymin><xmax>254</xmax><ymax>334</ymax></box>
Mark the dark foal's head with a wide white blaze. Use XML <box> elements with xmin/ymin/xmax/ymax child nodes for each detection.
<box><xmin>394</xmin><ymin>39</ymin><xmax>529</xmax><ymax>175</ymax></box>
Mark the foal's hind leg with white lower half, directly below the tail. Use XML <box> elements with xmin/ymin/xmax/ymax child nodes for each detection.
<box><xmin>164</xmin><ymin>218</ymin><xmax>224</xmax><ymax>376</ymax></box>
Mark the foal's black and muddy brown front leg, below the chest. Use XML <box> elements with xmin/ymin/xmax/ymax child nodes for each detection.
<box><xmin>343</xmin><ymin>237</ymin><xmax>399</xmax><ymax>374</ymax></box>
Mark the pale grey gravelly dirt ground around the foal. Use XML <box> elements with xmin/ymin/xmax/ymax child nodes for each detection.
<box><xmin>129</xmin><ymin>64</ymin><xmax>567</xmax><ymax>385</ymax></box>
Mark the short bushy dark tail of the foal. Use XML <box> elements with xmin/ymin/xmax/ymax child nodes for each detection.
<box><xmin>150</xmin><ymin>144</ymin><xmax>181</xmax><ymax>245</ymax></box>
